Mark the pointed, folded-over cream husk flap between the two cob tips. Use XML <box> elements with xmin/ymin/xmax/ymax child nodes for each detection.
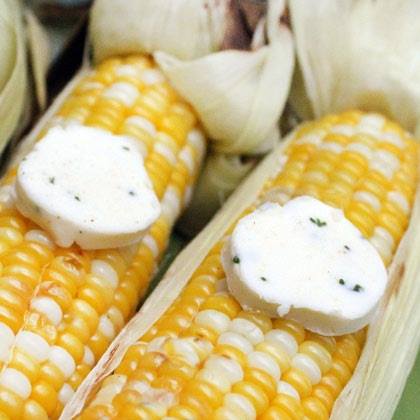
<box><xmin>155</xmin><ymin>0</ymin><xmax>293</xmax><ymax>154</ymax></box>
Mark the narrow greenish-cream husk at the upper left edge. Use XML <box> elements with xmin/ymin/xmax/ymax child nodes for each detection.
<box><xmin>0</xmin><ymin>0</ymin><xmax>26</xmax><ymax>152</ymax></box>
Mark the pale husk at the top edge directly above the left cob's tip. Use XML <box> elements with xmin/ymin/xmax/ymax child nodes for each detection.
<box><xmin>90</xmin><ymin>0</ymin><xmax>229</xmax><ymax>61</ymax></box>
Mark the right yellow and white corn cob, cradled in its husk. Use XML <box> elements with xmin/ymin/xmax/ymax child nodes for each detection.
<box><xmin>79</xmin><ymin>111</ymin><xmax>418</xmax><ymax>420</ymax></box>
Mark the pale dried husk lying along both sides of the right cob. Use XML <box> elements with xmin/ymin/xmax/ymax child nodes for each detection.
<box><xmin>62</xmin><ymin>129</ymin><xmax>420</xmax><ymax>420</ymax></box>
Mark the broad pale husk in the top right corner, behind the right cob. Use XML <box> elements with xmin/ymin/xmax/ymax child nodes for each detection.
<box><xmin>290</xmin><ymin>0</ymin><xmax>420</xmax><ymax>135</ymax></box>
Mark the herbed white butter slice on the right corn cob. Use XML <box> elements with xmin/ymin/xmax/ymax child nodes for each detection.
<box><xmin>222</xmin><ymin>196</ymin><xmax>387</xmax><ymax>335</ymax></box>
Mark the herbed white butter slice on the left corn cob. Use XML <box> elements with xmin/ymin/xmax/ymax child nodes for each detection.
<box><xmin>15</xmin><ymin>126</ymin><xmax>160</xmax><ymax>249</ymax></box>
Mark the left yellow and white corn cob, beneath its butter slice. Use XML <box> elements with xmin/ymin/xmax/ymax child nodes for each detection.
<box><xmin>0</xmin><ymin>56</ymin><xmax>204</xmax><ymax>419</ymax></box>
